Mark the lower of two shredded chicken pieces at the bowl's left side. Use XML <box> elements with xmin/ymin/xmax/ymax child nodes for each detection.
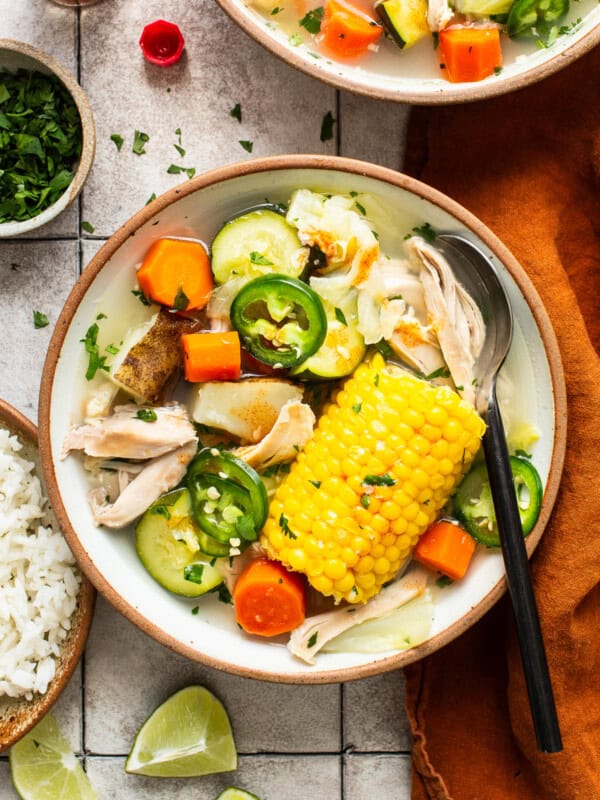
<box><xmin>89</xmin><ymin>439</ymin><xmax>198</xmax><ymax>528</ymax></box>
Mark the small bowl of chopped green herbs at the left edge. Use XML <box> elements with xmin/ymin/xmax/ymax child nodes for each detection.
<box><xmin>0</xmin><ymin>39</ymin><xmax>96</xmax><ymax>238</ymax></box>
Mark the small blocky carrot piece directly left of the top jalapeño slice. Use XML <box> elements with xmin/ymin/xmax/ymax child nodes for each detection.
<box><xmin>181</xmin><ymin>331</ymin><xmax>242</xmax><ymax>383</ymax></box>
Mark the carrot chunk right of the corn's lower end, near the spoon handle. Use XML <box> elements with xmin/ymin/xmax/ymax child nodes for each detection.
<box><xmin>413</xmin><ymin>520</ymin><xmax>476</xmax><ymax>581</ymax></box>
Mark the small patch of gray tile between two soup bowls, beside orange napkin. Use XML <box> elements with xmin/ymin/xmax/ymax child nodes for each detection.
<box><xmin>340</xmin><ymin>92</ymin><xmax>410</xmax><ymax>170</ymax></box>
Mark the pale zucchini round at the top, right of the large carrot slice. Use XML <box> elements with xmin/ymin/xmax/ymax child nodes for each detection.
<box><xmin>211</xmin><ymin>209</ymin><xmax>308</xmax><ymax>284</ymax></box>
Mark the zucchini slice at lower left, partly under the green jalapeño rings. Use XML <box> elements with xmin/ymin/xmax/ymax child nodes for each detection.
<box><xmin>135</xmin><ymin>489</ymin><xmax>229</xmax><ymax>597</ymax></box>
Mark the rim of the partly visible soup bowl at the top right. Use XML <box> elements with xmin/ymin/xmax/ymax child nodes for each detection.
<box><xmin>217</xmin><ymin>0</ymin><xmax>600</xmax><ymax>106</ymax></box>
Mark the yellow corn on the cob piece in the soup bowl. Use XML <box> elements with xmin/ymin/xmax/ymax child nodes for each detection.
<box><xmin>261</xmin><ymin>355</ymin><xmax>485</xmax><ymax>603</ymax></box>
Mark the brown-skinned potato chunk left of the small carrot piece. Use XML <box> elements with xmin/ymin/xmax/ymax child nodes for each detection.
<box><xmin>108</xmin><ymin>308</ymin><xmax>198</xmax><ymax>403</ymax></box>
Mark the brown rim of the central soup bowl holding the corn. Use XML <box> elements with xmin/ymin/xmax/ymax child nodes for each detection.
<box><xmin>39</xmin><ymin>155</ymin><xmax>567</xmax><ymax>684</ymax></box>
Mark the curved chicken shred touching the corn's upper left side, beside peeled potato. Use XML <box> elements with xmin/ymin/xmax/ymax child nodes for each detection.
<box><xmin>233</xmin><ymin>400</ymin><xmax>316</xmax><ymax>468</ymax></box>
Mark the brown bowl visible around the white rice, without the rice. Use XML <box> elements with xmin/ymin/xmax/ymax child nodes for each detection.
<box><xmin>0</xmin><ymin>400</ymin><xmax>96</xmax><ymax>752</ymax></box>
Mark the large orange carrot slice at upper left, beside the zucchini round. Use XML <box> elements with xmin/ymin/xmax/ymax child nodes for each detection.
<box><xmin>137</xmin><ymin>238</ymin><xmax>213</xmax><ymax>311</ymax></box>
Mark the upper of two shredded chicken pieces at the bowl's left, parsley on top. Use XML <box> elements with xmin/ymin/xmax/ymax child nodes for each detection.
<box><xmin>61</xmin><ymin>403</ymin><xmax>196</xmax><ymax>459</ymax></box>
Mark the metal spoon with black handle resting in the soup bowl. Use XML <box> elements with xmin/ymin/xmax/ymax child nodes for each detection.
<box><xmin>435</xmin><ymin>233</ymin><xmax>562</xmax><ymax>753</ymax></box>
